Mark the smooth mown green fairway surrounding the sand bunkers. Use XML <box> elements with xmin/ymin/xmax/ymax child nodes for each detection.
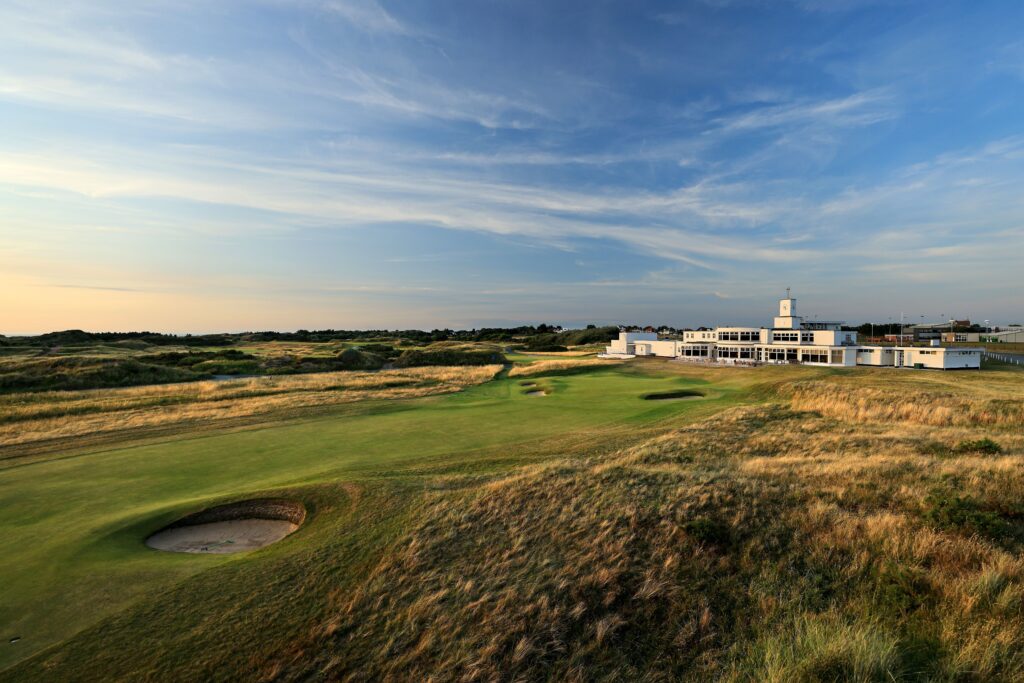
<box><xmin>0</xmin><ymin>368</ymin><xmax>737</xmax><ymax>667</ymax></box>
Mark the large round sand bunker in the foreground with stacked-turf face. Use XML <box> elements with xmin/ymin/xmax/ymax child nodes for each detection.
<box><xmin>145</xmin><ymin>499</ymin><xmax>306</xmax><ymax>555</ymax></box>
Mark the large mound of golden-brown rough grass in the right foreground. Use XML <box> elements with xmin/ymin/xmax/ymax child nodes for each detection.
<box><xmin>268</xmin><ymin>389</ymin><xmax>1024</xmax><ymax>682</ymax></box>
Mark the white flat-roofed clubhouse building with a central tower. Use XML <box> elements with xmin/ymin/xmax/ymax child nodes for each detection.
<box><xmin>601</xmin><ymin>290</ymin><xmax>981</xmax><ymax>370</ymax></box>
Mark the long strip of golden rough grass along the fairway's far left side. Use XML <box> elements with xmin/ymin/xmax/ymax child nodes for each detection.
<box><xmin>0</xmin><ymin>366</ymin><xmax>502</xmax><ymax>445</ymax></box>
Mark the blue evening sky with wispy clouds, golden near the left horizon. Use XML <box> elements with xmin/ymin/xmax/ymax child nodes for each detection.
<box><xmin>0</xmin><ymin>0</ymin><xmax>1024</xmax><ymax>335</ymax></box>
